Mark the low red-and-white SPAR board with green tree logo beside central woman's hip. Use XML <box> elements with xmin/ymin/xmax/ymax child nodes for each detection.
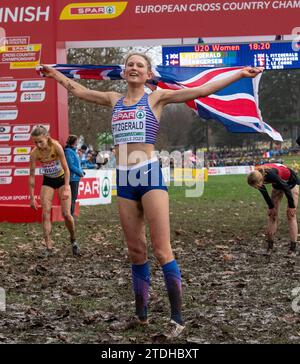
<box><xmin>78</xmin><ymin>170</ymin><xmax>112</xmax><ymax>205</ymax></box>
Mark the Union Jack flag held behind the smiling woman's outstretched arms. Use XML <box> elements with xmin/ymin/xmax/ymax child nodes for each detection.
<box><xmin>41</xmin><ymin>64</ymin><xmax>282</xmax><ymax>141</ymax></box>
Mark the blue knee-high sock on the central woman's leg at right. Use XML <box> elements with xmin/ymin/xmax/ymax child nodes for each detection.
<box><xmin>162</xmin><ymin>259</ymin><xmax>183</xmax><ymax>325</ymax></box>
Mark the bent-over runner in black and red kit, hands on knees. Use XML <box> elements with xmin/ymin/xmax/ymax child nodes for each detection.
<box><xmin>248</xmin><ymin>163</ymin><xmax>300</xmax><ymax>255</ymax></box>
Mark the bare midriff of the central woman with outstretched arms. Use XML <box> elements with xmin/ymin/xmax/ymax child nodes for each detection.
<box><xmin>115</xmin><ymin>143</ymin><xmax>155</xmax><ymax>166</ymax></box>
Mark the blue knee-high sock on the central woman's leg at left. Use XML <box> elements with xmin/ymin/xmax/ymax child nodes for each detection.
<box><xmin>132</xmin><ymin>262</ymin><xmax>150</xmax><ymax>321</ymax></box>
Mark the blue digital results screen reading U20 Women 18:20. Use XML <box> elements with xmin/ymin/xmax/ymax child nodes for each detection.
<box><xmin>162</xmin><ymin>41</ymin><xmax>300</xmax><ymax>70</ymax></box>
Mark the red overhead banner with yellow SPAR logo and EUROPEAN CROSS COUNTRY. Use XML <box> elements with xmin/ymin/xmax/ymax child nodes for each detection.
<box><xmin>57</xmin><ymin>0</ymin><xmax>300</xmax><ymax>41</ymax></box>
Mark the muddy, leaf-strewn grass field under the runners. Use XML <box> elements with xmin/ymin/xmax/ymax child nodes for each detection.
<box><xmin>0</xmin><ymin>171</ymin><xmax>300</xmax><ymax>343</ymax></box>
